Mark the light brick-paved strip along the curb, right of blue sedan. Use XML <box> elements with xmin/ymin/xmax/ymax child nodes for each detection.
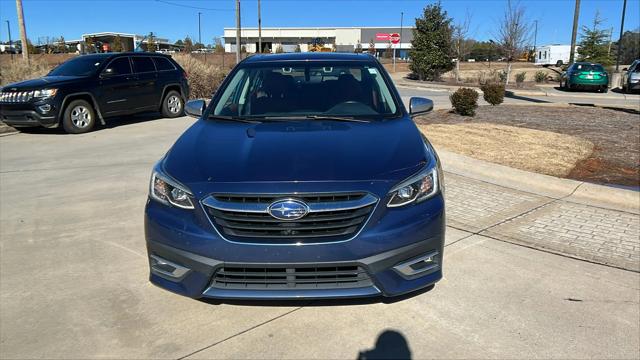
<box><xmin>445</xmin><ymin>173</ymin><xmax>640</xmax><ymax>271</ymax></box>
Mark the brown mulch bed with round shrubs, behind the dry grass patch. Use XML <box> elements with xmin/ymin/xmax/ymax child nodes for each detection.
<box><xmin>416</xmin><ymin>105</ymin><xmax>640</xmax><ymax>188</ymax></box>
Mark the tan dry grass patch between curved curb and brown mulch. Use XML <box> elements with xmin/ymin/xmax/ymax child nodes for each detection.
<box><xmin>419</xmin><ymin>123</ymin><xmax>593</xmax><ymax>177</ymax></box>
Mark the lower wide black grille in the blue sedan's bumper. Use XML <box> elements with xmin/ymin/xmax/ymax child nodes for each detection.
<box><xmin>211</xmin><ymin>265</ymin><xmax>373</xmax><ymax>290</ymax></box>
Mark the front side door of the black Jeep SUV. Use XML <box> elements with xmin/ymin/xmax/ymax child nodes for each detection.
<box><xmin>98</xmin><ymin>56</ymin><xmax>136</xmax><ymax>115</ymax></box>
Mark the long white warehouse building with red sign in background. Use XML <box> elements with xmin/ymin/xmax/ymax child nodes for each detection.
<box><xmin>223</xmin><ymin>27</ymin><xmax>413</xmax><ymax>58</ymax></box>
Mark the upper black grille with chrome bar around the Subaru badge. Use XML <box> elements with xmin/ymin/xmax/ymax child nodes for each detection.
<box><xmin>204</xmin><ymin>193</ymin><xmax>377</xmax><ymax>243</ymax></box>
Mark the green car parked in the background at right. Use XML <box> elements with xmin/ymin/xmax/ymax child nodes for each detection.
<box><xmin>560</xmin><ymin>62</ymin><xmax>609</xmax><ymax>92</ymax></box>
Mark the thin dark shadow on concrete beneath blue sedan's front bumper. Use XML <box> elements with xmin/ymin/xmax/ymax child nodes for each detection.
<box><xmin>198</xmin><ymin>285</ymin><xmax>435</xmax><ymax>307</ymax></box>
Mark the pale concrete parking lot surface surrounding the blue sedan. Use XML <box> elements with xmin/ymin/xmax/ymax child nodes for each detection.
<box><xmin>0</xmin><ymin>116</ymin><xmax>640</xmax><ymax>359</ymax></box>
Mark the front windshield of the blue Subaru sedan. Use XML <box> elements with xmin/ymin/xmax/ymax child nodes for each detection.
<box><xmin>212</xmin><ymin>62</ymin><xmax>398</xmax><ymax>119</ymax></box>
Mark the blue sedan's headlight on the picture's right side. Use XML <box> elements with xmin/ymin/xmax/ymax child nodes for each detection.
<box><xmin>387</xmin><ymin>166</ymin><xmax>440</xmax><ymax>207</ymax></box>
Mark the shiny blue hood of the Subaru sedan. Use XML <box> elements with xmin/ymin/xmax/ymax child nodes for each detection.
<box><xmin>163</xmin><ymin>118</ymin><xmax>427</xmax><ymax>185</ymax></box>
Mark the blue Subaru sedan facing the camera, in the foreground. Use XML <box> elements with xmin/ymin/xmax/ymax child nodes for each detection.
<box><xmin>145</xmin><ymin>53</ymin><xmax>445</xmax><ymax>299</ymax></box>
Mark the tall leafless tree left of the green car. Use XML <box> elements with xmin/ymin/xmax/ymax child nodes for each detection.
<box><xmin>496</xmin><ymin>0</ymin><xmax>531</xmax><ymax>84</ymax></box>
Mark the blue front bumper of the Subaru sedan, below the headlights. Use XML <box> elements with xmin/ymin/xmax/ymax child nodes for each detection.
<box><xmin>145</xmin><ymin>191</ymin><xmax>445</xmax><ymax>299</ymax></box>
